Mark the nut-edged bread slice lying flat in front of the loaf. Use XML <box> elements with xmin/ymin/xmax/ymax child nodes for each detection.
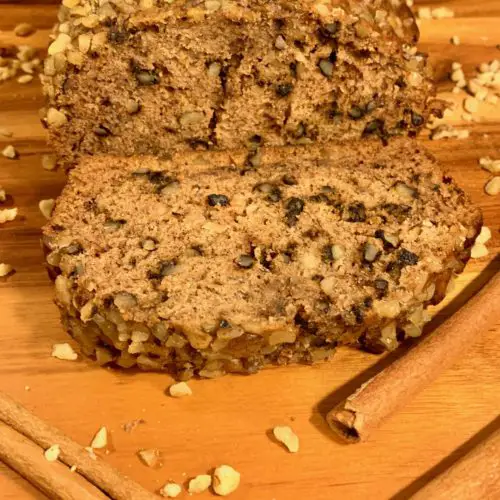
<box><xmin>43</xmin><ymin>139</ymin><xmax>481</xmax><ymax>379</ymax></box>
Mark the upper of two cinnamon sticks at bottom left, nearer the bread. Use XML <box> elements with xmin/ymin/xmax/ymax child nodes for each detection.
<box><xmin>0</xmin><ymin>392</ymin><xmax>158</xmax><ymax>500</ymax></box>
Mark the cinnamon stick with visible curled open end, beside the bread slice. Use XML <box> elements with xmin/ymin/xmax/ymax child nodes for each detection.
<box><xmin>326</xmin><ymin>273</ymin><xmax>500</xmax><ymax>443</ymax></box>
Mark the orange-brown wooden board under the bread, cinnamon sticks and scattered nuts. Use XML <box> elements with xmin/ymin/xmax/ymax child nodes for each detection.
<box><xmin>0</xmin><ymin>0</ymin><xmax>500</xmax><ymax>500</ymax></box>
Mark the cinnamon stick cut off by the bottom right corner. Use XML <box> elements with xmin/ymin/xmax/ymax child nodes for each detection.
<box><xmin>412</xmin><ymin>429</ymin><xmax>500</xmax><ymax>500</ymax></box>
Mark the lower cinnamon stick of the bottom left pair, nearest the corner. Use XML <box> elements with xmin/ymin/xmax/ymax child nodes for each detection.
<box><xmin>0</xmin><ymin>422</ymin><xmax>109</xmax><ymax>500</ymax></box>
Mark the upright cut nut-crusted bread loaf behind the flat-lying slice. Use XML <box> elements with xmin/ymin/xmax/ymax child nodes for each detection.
<box><xmin>43</xmin><ymin>0</ymin><xmax>440</xmax><ymax>165</ymax></box>
